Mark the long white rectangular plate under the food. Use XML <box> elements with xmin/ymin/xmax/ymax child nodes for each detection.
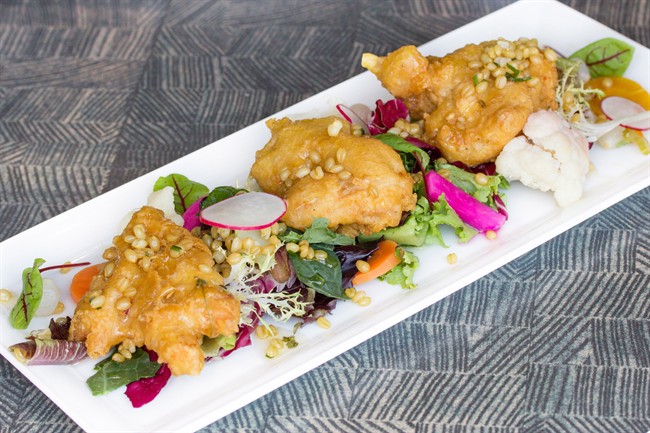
<box><xmin>0</xmin><ymin>1</ymin><xmax>650</xmax><ymax>431</ymax></box>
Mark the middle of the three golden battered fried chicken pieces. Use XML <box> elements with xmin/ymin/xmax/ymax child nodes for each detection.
<box><xmin>251</xmin><ymin>117</ymin><xmax>416</xmax><ymax>236</ymax></box>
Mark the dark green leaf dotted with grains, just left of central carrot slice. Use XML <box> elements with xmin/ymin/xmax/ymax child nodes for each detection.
<box><xmin>289</xmin><ymin>248</ymin><xmax>348</xmax><ymax>299</ymax></box>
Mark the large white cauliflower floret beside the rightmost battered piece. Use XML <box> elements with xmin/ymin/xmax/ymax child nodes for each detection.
<box><xmin>496</xmin><ymin>111</ymin><xmax>590</xmax><ymax>207</ymax></box>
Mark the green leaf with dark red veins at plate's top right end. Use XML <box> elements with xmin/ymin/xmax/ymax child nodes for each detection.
<box><xmin>569</xmin><ymin>38</ymin><xmax>634</xmax><ymax>78</ymax></box>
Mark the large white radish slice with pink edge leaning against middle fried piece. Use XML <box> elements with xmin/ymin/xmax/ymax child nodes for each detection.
<box><xmin>201</xmin><ymin>192</ymin><xmax>287</xmax><ymax>230</ymax></box>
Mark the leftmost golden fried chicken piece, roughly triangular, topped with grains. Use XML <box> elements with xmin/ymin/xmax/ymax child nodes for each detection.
<box><xmin>70</xmin><ymin>206</ymin><xmax>239</xmax><ymax>375</ymax></box>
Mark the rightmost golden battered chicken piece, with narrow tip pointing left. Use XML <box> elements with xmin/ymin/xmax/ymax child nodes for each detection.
<box><xmin>362</xmin><ymin>40</ymin><xmax>557</xmax><ymax>166</ymax></box>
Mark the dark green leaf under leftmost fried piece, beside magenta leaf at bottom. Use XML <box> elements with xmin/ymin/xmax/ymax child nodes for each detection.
<box><xmin>86</xmin><ymin>348</ymin><xmax>160</xmax><ymax>395</ymax></box>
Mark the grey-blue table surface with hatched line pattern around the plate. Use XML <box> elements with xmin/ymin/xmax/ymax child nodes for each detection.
<box><xmin>0</xmin><ymin>0</ymin><xmax>650</xmax><ymax>433</ymax></box>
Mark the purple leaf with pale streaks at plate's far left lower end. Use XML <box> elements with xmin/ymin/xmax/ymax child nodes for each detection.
<box><xmin>9</xmin><ymin>338</ymin><xmax>86</xmax><ymax>365</ymax></box>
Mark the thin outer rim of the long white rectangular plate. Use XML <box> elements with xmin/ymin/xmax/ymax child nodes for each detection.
<box><xmin>0</xmin><ymin>0</ymin><xmax>650</xmax><ymax>431</ymax></box>
